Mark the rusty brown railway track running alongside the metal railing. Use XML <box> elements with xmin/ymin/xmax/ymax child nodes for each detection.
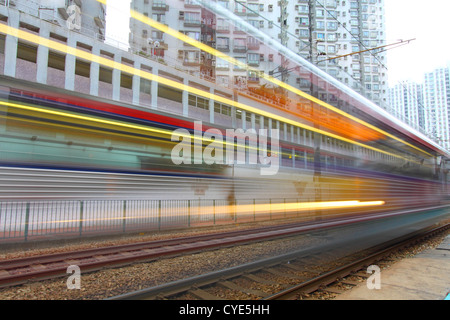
<box><xmin>0</xmin><ymin>214</ymin><xmax>398</xmax><ymax>287</ymax></box>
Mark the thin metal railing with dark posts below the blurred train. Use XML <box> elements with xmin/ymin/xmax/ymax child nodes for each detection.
<box><xmin>0</xmin><ymin>199</ymin><xmax>314</xmax><ymax>243</ymax></box>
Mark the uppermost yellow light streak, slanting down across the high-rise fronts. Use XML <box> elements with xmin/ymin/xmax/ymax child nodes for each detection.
<box><xmin>110</xmin><ymin>0</ymin><xmax>431</xmax><ymax>156</ymax></box>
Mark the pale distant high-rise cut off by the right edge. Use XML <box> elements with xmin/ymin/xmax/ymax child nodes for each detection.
<box><xmin>423</xmin><ymin>68</ymin><xmax>450</xmax><ymax>150</ymax></box>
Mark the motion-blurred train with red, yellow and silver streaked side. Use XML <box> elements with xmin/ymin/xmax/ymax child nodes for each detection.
<box><xmin>0</xmin><ymin>76</ymin><xmax>448</xmax><ymax>222</ymax></box>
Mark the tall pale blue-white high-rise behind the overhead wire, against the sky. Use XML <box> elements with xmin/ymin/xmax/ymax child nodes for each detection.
<box><xmin>288</xmin><ymin>0</ymin><xmax>387</xmax><ymax>107</ymax></box>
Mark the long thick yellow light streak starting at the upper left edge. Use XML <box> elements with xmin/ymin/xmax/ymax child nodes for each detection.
<box><xmin>0</xmin><ymin>23</ymin><xmax>412</xmax><ymax>161</ymax></box>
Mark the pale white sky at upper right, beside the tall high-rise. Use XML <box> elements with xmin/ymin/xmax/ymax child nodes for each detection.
<box><xmin>385</xmin><ymin>0</ymin><xmax>450</xmax><ymax>86</ymax></box>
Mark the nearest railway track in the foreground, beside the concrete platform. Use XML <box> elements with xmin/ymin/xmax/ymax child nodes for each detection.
<box><xmin>110</xmin><ymin>224</ymin><xmax>450</xmax><ymax>300</ymax></box>
